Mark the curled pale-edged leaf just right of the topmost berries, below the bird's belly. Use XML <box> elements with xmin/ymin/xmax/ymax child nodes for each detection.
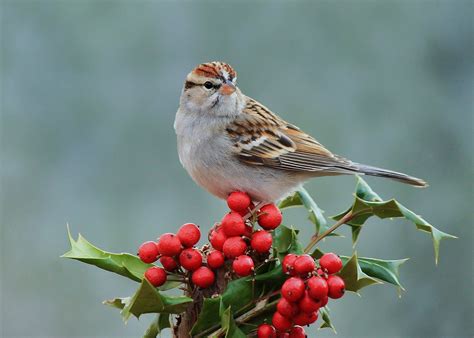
<box><xmin>279</xmin><ymin>187</ymin><xmax>328</xmax><ymax>235</ymax></box>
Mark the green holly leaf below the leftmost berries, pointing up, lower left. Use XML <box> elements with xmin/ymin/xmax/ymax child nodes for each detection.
<box><xmin>119</xmin><ymin>279</ymin><xmax>193</xmax><ymax>322</ymax></box>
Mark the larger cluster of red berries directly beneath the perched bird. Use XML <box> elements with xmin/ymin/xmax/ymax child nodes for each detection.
<box><xmin>138</xmin><ymin>192</ymin><xmax>282</xmax><ymax>288</ymax></box>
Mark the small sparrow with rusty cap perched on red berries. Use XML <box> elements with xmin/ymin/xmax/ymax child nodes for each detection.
<box><xmin>174</xmin><ymin>61</ymin><xmax>427</xmax><ymax>203</ymax></box>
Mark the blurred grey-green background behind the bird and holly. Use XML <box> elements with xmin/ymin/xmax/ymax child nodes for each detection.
<box><xmin>0</xmin><ymin>0</ymin><xmax>474</xmax><ymax>337</ymax></box>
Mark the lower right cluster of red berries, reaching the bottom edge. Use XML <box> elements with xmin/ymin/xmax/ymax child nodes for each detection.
<box><xmin>257</xmin><ymin>253</ymin><xmax>345</xmax><ymax>338</ymax></box>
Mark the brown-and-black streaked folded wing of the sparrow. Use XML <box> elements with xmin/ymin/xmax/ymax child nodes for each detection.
<box><xmin>226</xmin><ymin>98</ymin><xmax>357</xmax><ymax>174</ymax></box>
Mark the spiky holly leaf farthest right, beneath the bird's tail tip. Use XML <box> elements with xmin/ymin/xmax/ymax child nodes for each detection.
<box><xmin>333</xmin><ymin>177</ymin><xmax>457</xmax><ymax>264</ymax></box>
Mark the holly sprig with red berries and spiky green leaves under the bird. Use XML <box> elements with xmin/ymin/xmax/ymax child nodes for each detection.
<box><xmin>62</xmin><ymin>177</ymin><xmax>455</xmax><ymax>338</ymax></box>
